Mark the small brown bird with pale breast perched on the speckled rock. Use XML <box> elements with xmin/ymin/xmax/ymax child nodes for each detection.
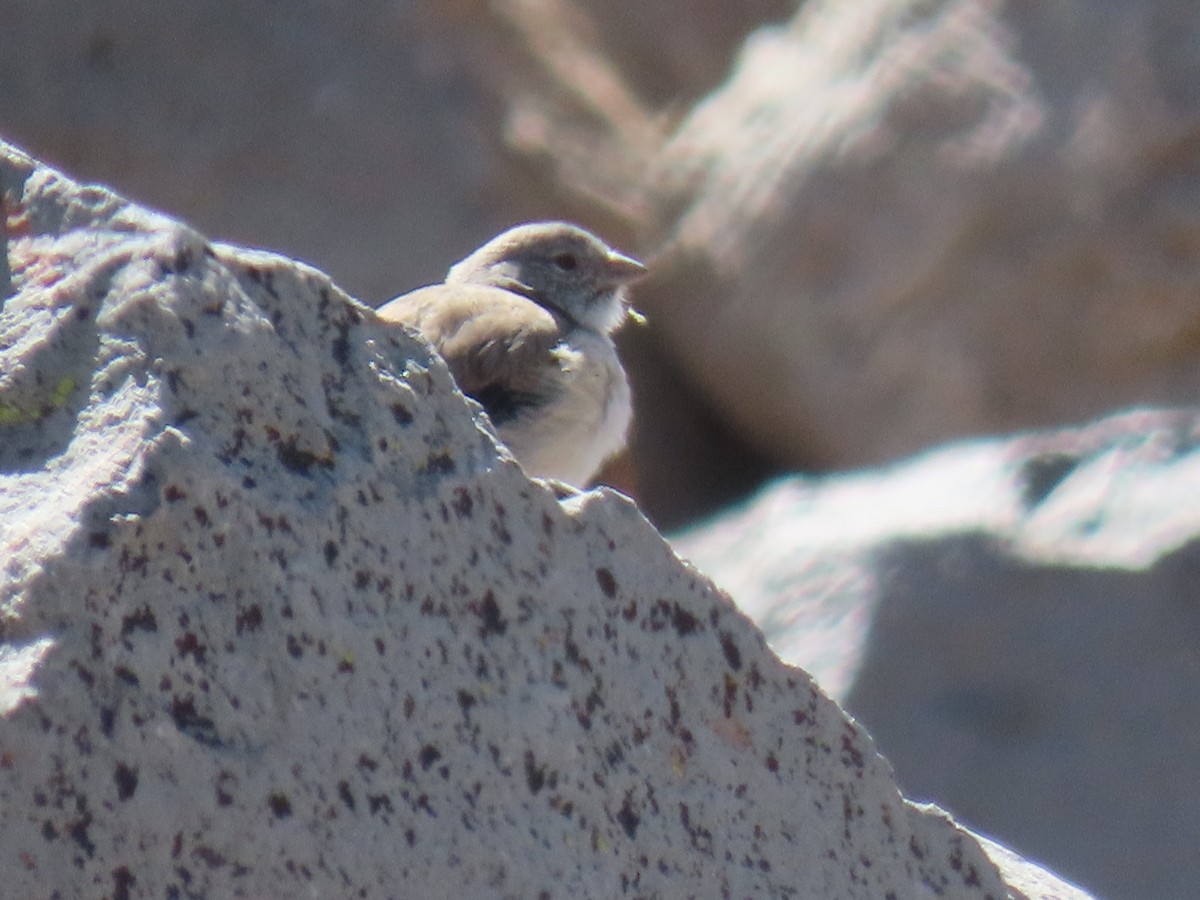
<box><xmin>377</xmin><ymin>222</ymin><xmax>646</xmax><ymax>487</ymax></box>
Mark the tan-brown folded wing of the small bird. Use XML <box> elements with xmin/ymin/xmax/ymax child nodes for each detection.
<box><xmin>376</xmin><ymin>284</ymin><xmax>563</xmax><ymax>425</ymax></box>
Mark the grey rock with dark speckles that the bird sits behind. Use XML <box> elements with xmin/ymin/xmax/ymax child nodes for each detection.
<box><xmin>0</xmin><ymin>149</ymin><xmax>1082</xmax><ymax>900</ymax></box>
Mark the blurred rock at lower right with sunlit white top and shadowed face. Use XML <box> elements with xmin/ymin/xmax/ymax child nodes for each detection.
<box><xmin>673</xmin><ymin>410</ymin><xmax>1200</xmax><ymax>900</ymax></box>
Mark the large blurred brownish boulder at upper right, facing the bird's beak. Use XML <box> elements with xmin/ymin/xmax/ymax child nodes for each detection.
<box><xmin>638</xmin><ymin>0</ymin><xmax>1200</xmax><ymax>469</ymax></box>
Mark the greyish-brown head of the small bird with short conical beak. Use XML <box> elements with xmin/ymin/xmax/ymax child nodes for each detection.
<box><xmin>446</xmin><ymin>222</ymin><xmax>646</xmax><ymax>335</ymax></box>
